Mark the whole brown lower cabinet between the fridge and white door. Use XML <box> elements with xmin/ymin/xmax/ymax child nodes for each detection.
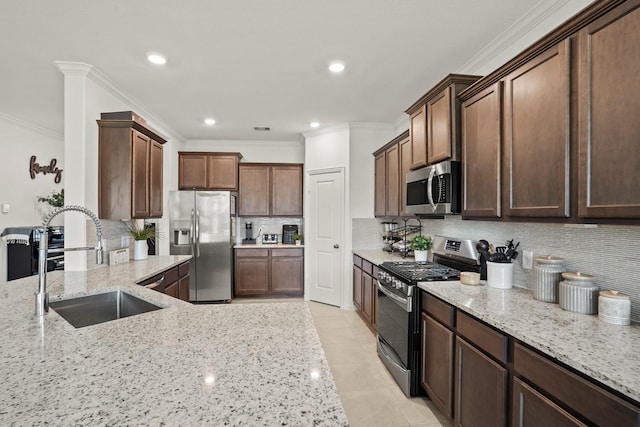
<box><xmin>234</xmin><ymin>248</ymin><xmax>304</xmax><ymax>297</ymax></box>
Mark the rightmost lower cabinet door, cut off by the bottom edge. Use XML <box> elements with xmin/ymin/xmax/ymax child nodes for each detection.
<box><xmin>512</xmin><ymin>378</ymin><xmax>586</xmax><ymax>427</ymax></box>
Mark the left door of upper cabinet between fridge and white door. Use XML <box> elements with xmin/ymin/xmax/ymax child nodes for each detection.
<box><xmin>238</xmin><ymin>165</ymin><xmax>271</xmax><ymax>216</ymax></box>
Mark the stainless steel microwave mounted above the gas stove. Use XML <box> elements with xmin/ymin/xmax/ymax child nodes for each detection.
<box><xmin>405</xmin><ymin>160</ymin><xmax>462</xmax><ymax>215</ymax></box>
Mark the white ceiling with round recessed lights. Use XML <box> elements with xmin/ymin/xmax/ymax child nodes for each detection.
<box><xmin>0</xmin><ymin>0</ymin><xmax>576</xmax><ymax>141</ymax></box>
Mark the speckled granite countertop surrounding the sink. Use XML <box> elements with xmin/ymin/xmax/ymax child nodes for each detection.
<box><xmin>0</xmin><ymin>256</ymin><xmax>347</xmax><ymax>426</ymax></box>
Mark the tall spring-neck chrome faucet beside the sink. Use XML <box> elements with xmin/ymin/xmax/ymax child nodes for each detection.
<box><xmin>36</xmin><ymin>206</ymin><xmax>102</xmax><ymax>316</ymax></box>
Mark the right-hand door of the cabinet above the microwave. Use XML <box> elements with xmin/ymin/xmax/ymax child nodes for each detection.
<box><xmin>427</xmin><ymin>87</ymin><xmax>452</xmax><ymax>164</ymax></box>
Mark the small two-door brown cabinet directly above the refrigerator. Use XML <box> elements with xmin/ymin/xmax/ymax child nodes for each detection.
<box><xmin>178</xmin><ymin>152</ymin><xmax>242</xmax><ymax>191</ymax></box>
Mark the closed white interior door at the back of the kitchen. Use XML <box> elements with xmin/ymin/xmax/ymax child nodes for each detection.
<box><xmin>305</xmin><ymin>169</ymin><xmax>344</xmax><ymax>306</ymax></box>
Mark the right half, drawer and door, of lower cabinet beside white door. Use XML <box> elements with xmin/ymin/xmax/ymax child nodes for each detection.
<box><xmin>271</xmin><ymin>249</ymin><xmax>304</xmax><ymax>295</ymax></box>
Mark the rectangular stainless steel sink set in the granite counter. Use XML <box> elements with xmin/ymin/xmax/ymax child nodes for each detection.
<box><xmin>49</xmin><ymin>290</ymin><xmax>162</xmax><ymax>328</ymax></box>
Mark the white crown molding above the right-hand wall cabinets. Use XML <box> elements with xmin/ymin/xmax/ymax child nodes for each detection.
<box><xmin>456</xmin><ymin>0</ymin><xmax>571</xmax><ymax>73</ymax></box>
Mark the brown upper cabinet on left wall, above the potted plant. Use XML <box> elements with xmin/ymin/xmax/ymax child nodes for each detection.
<box><xmin>97</xmin><ymin>112</ymin><xmax>166</xmax><ymax>220</ymax></box>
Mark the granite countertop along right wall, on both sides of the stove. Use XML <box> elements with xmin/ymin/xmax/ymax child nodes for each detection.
<box><xmin>354</xmin><ymin>250</ymin><xmax>640</xmax><ymax>402</ymax></box>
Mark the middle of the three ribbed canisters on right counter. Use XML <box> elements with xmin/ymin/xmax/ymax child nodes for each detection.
<box><xmin>558</xmin><ymin>272</ymin><xmax>600</xmax><ymax>314</ymax></box>
